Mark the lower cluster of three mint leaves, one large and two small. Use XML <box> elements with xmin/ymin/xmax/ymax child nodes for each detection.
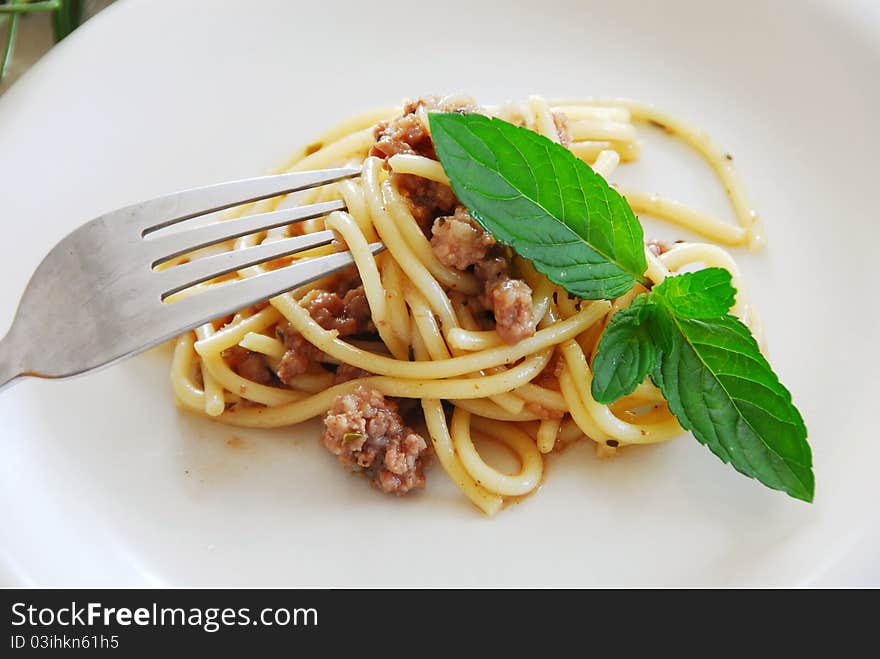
<box><xmin>592</xmin><ymin>268</ymin><xmax>814</xmax><ymax>501</ymax></box>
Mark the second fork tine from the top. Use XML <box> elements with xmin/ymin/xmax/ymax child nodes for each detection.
<box><xmin>145</xmin><ymin>199</ymin><xmax>345</xmax><ymax>267</ymax></box>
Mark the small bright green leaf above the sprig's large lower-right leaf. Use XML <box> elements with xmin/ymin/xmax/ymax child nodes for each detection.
<box><xmin>651</xmin><ymin>268</ymin><xmax>736</xmax><ymax>318</ymax></box>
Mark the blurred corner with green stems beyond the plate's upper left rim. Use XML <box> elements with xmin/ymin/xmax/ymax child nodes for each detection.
<box><xmin>0</xmin><ymin>0</ymin><xmax>113</xmax><ymax>94</ymax></box>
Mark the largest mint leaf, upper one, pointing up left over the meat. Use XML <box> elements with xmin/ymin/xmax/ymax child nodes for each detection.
<box><xmin>429</xmin><ymin>113</ymin><xmax>647</xmax><ymax>300</ymax></box>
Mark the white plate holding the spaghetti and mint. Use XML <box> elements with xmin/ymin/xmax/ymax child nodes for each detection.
<box><xmin>0</xmin><ymin>0</ymin><xmax>880</xmax><ymax>585</ymax></box>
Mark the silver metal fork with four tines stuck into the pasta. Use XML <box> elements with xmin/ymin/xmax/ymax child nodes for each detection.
<box><xmin>0</xmin><ymin>168</ymin><xmax>384</xmax><ymax>388</ymax></box>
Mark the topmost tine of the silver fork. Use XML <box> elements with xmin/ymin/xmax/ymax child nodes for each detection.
<box><xmin>133</xmin><ymin>167</ymin><xmax>361</xmax><ymax>236</ymax></box>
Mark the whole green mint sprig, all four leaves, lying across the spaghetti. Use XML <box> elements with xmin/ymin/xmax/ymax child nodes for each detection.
<box><xmin>429</xmin><ymin>113</ymin><xmax>814</xmax><ymax>501</ymax></box>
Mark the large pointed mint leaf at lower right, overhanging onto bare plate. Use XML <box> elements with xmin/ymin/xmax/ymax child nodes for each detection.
<box><xmin>650</xmin><ymin>312</ymin><xmax>814</xmax><ymax>501</ymax></box>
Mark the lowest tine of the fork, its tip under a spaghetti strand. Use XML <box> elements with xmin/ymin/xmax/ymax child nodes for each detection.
<box><xmin>164</xmin><ymin>242</ymin><xmax>385</xmax><ymax>334</ymax></box>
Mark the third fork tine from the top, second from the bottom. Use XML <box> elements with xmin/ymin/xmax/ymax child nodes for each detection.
<box><xmin>156</xmin><ymin>231</ymin><xmax>334</xmax><ymax>300</ymax></box>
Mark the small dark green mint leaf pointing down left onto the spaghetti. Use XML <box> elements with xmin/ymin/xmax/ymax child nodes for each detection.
<box><xmin>592</xmin><ymin>294</ymin><xmax>657</xmax><ymax>405</ymax></box>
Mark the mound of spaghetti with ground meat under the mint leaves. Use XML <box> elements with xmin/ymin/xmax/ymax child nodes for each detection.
<box><xmin>171</xmin><ymin>96</ymin><xmax>763</xmax><ymax>515</ymax></box>
